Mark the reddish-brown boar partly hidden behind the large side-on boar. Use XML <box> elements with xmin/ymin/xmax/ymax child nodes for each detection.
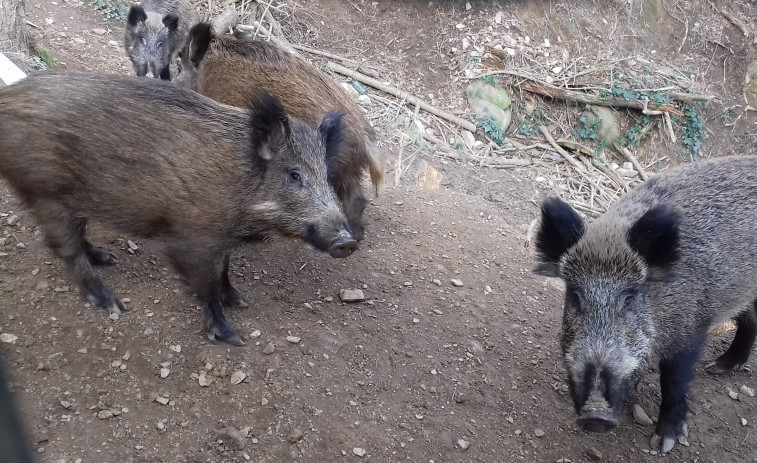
<box><xmin>177</xmin><ymin>23</ymin><xmax>384</xmax><ymax>240</ymax></box>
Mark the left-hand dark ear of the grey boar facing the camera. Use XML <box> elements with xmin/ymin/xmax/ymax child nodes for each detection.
<box><xmin>534</xmin><ymin>197</ymin><xmax>585</xmax><ymax>277</ymax></box>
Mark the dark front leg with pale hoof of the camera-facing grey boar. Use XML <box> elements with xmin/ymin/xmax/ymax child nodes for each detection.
<box><xmin>650</xmin><ymin>338</ymin><xmax>704</xmax><ymax>453</ymax></box>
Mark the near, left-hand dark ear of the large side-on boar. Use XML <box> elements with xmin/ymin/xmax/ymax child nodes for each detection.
<box><xmin>249</xmin><ymin>90</ymin><xmax>290</xmax><ymax>161</ymax></box>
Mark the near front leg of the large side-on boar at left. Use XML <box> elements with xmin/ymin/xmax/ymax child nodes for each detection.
<box><xmin>168</xmin><ymin>245</ymin><xmax>244</xmax><ymax>346</ymax></box>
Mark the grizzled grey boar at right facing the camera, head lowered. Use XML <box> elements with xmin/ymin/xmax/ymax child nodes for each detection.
<box><xmin>535</xmin><ymin>156</ymin><xmax>757</xmax><ymax>452</ymax></box>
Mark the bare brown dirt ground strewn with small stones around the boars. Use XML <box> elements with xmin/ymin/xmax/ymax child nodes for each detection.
<box><xmin>0</xmin><ymin>0</ymin><xmax>757</xmax><ymax>463</ymax></box>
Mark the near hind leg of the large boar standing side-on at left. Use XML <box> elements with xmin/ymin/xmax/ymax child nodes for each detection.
<box><xmin>33</xmin><ymin>201</ymin><xmax>124</xmax><ymax>315</ymax></box>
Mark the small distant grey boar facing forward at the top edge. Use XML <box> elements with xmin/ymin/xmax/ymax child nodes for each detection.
<box><xmin>124</xmin><ymin>0</ymin><xmax>197</xmax><ymax>80</ymax></box>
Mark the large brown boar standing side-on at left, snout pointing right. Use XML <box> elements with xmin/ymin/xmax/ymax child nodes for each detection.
<box><xmin>0</xmin><ymin>74</ymin><xmax>357</xmax><ymax>345</ymax></box>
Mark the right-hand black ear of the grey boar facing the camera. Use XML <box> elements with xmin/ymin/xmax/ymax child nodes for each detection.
<box><xmin>628</xmin><ymin>205</ymin><xmax>680</xmax><ymax>267</ymax></box>
